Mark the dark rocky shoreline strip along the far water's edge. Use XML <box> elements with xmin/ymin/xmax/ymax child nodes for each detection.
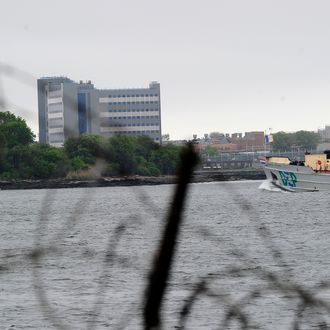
<box><xmin>0</xmin><ymin>168</ymin><xmax>266</xmax><ymax>190</ymax></box>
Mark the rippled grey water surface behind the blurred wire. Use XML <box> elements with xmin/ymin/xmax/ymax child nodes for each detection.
<box><xmin>0</xmin><ymin>182</ymin><xmax>330</xmax><ymax>329</ymax></box>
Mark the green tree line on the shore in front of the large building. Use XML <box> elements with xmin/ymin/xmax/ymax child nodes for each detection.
<box><xmin>0</xmin><ymin>112</ymin><xmax>181</xmax><ymax>180</ymax></box>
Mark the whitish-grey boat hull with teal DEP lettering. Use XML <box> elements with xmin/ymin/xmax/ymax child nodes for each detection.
<box><xmin>264</xmin><ymin>164</ymin><xmax>330</xmax><ymax>191</ymax></box>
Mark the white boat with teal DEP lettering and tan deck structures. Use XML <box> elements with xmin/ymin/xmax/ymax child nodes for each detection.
<box><xmin>264</xmin><ymin>151</ymin><xmax>330</xmax><ymax>191</ymax></box>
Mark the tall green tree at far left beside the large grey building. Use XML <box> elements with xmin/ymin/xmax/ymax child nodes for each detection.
<box><xmin>0</xmin><ymin>111</ymin><xmax>35</xmax><ymax>149</ymax></box>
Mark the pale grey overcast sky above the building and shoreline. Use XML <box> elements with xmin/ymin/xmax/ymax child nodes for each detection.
<box><xmin>0</xmin><ymin>0</ymin><xmax>330</xmax><ymax>139</ymax></box>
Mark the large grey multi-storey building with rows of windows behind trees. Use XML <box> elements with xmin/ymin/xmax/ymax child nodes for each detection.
<box><xmin>38</xmin><ymin>77</ymin><xmax>161</xmax><ymax>146</ymax></box>
